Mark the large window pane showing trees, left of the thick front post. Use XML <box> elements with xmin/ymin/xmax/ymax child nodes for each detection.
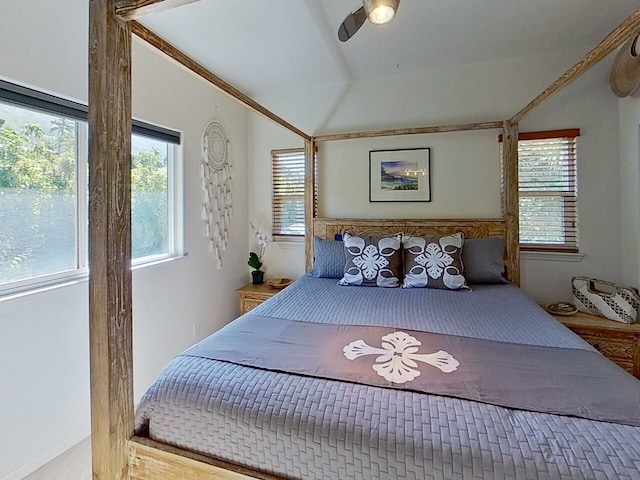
<box><xmin>0</xmin><ymin>107</ymin><xmax>86</xmax><ymax>285</ymax></box>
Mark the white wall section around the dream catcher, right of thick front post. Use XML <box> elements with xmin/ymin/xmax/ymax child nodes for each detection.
<box><xmin>133</xmin><ymin>37</ymin><xmax>249</xmax><ymax>398</ymax></box>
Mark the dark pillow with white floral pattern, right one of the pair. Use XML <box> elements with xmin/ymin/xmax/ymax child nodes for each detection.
<box><xmin>402</xmin><ymin>233</ymin><xmax>469</xmax><ymax>290</ymax></box>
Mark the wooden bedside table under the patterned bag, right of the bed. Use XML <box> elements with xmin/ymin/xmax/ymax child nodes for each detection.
<box><xmin>553</xmin><ymin>312</ymin><xmax>640</xmax><ymax>378</ymax></box>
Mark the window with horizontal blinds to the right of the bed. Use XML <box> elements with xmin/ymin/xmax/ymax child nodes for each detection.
<box><xmin>500</xmin><ymin>129</ymin><xmax>580</xmax><ymax>252</ymax></box>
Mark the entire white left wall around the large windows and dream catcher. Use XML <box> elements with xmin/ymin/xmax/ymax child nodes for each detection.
<box><xmin>0</xmin><ymin>0</ymin><xmax>249</xmax><ymax>480</ymax></box>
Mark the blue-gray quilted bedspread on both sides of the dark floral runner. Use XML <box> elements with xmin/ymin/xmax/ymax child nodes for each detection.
<box><xmin>136</xmin><ymin>277</ymin><xmax>640</xmax><ymax>479</ymax></box>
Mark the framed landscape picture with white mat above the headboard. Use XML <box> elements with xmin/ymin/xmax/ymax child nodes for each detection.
<box><xmin>369</xmin><ymin>148</ymin><xmax>431</xmax><ymax>202</ymax></box>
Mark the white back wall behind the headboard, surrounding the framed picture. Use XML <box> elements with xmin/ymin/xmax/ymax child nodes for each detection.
<box><xmin>249</xmin><ymin>48</ymin><xmax>624</xmax><ymax>304</ymax></box>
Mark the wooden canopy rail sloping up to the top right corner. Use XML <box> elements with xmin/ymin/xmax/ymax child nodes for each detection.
<box><xmin>509</xmin><ymin>8</ymin><xmax>640</xmax><ymax>124</ymax></box>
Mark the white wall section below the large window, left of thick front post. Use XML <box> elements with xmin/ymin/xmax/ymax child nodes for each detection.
<box><xmin>0</xmin><ymin>282</ymin><xmax>90</xmax><ymax>479</ymax></box>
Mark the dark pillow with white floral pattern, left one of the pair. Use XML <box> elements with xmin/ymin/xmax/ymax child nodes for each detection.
<box><xmin>338</xmin><ymin>232</ymin><xmax>402</xmax><ymax>287</ymax></box>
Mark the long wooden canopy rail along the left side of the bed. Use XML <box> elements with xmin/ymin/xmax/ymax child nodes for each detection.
<box><xmin>129</xmin><ymin>20</ymin><xmax>311</xmax><ymax>141</ymax></box>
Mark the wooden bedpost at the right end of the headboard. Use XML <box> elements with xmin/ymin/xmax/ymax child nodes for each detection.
<box><xmin>502</xmin><ymin>120</ymin><xmax>520</xmax><ymax>286</ymax></box>
